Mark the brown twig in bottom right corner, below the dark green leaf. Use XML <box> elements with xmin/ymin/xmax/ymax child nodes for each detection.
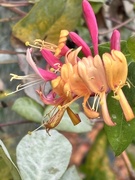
<box><xmin>121</xmin><ymin>151</ymin><xmax>135</xmax><ymax>180</ymax></box>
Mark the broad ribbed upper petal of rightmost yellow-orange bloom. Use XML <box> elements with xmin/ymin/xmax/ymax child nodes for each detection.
<box><xmin>103</xmin><ymin>50</ymin><xmax>128</xmax><ymax>90</ymax></box>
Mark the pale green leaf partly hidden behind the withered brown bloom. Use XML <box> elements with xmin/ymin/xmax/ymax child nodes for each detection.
<box><xmin>44</xmin><ymin>103</ymin><xmax>93</xmax><ymax>133</ymax></box>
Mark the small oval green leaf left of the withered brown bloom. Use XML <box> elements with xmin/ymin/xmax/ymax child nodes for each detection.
<box><xmin>12</xmin><ymin>97</ymin><xmax>44</xmax><ymax>122</ymax></box>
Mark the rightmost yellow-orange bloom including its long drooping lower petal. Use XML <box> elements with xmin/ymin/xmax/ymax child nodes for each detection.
<box><xmin>103</xmin><ymin>50</ymin><xmax>135</xmax><ymax>121</ymax></box>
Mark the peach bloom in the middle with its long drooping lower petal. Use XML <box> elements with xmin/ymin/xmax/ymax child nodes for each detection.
<box><xmin>78</xmin><ymin>55</ymin><xmax>115</xmax><ymax>126</ymax></box>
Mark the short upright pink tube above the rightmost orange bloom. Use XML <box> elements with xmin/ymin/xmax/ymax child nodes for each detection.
<box><xmin>111</xmin><ymin>30</ymin><xmax>120</xmax><ymax>51</ymax></box>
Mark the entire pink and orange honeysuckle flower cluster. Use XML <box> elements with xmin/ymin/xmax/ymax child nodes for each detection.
<box><xmin>8</xmin><ymin>0</ymin><xmax>134</xmax><ymax>130</ymax></box>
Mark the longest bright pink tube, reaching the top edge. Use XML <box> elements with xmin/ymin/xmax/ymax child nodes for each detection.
<box><xmin>82</xmin><ymin>0</ymin><xmax>98</xmax><ymax>55</ymax></box>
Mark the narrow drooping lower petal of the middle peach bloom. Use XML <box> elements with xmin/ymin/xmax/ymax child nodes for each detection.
<box><xmin>101</xmin><ymin>93</ymin><xmax>116</xmax><ymax>126</ymax></box>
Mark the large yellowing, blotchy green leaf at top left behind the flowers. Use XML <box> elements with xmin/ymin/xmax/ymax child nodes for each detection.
<box><xmin>13</xmin><ymin>0</ymin><xmax>82</xmax><ymax>44</ymax></box>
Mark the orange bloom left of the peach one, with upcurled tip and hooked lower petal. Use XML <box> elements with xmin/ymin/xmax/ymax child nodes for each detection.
<box><xmin>51</xmin><ymin>48</ymin><xmax>99</xmax><ymax>123</ymax></box>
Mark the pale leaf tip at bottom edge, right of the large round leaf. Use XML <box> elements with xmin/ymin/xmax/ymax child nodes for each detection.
<box><xmin>60</xmin><ymin>166</ymin><xmax>81</xmax><ymax>180</ymax></box>
